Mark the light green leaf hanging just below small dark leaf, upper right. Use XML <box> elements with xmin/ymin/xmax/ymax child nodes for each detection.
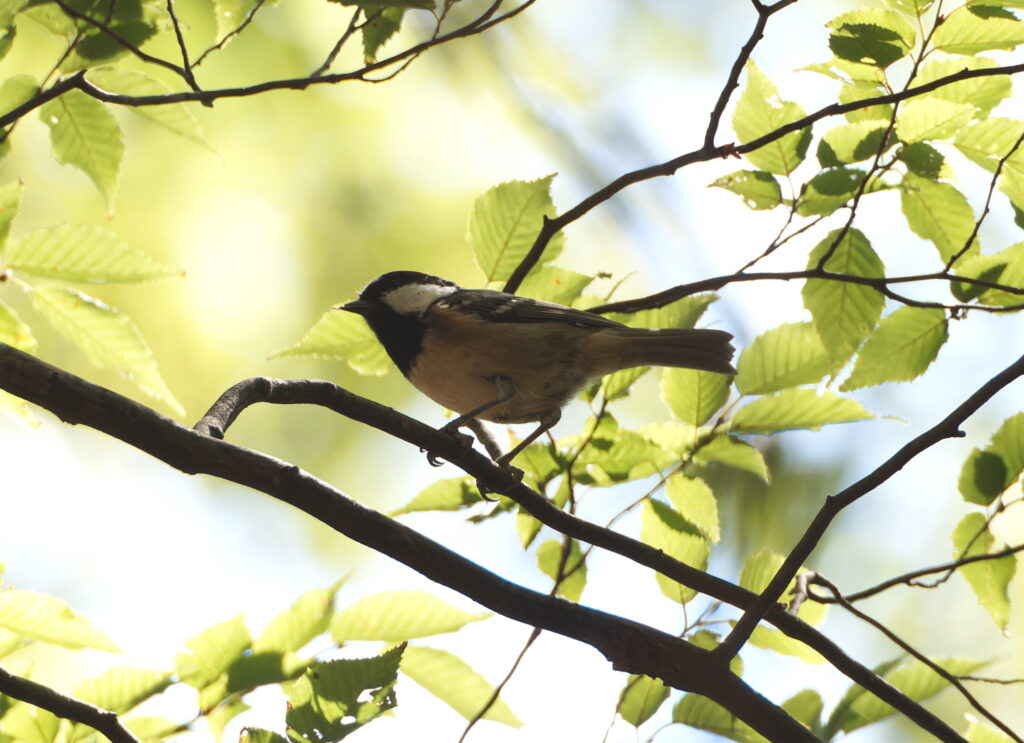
<box><xmin>900</xmin><ymin>173</ymin><xmax>978</xmax><ymax>261</ymax></box>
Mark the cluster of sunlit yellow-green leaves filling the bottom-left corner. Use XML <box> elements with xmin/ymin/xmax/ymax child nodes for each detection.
<box><xmin>0</xmin><ymin>569</ymin><xmax>520</xmax><ymax>743</ymax></box>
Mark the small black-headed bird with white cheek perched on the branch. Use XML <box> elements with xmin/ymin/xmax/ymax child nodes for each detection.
<box><xmin>337</xmin><ymin>271</ymin><xmax>736</xmax><ymax>466</ymax></box>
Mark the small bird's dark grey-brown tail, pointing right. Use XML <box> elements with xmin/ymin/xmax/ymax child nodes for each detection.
<box><xmin>615</xmin><ymin>327</ymin><xmax>736</xmax><ymax>375</ymax></box>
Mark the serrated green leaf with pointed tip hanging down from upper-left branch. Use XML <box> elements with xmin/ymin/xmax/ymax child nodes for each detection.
<box><xmin>39</xmin><ymin>90</ymin><xmax>125</xmax><ymax>209</ymax></box>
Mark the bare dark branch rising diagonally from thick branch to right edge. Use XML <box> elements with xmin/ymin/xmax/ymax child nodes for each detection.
<box><xmin>712</xmin><ymin>356</ymin><xmax>1024</xmax><ymax>658</ymax></box>
